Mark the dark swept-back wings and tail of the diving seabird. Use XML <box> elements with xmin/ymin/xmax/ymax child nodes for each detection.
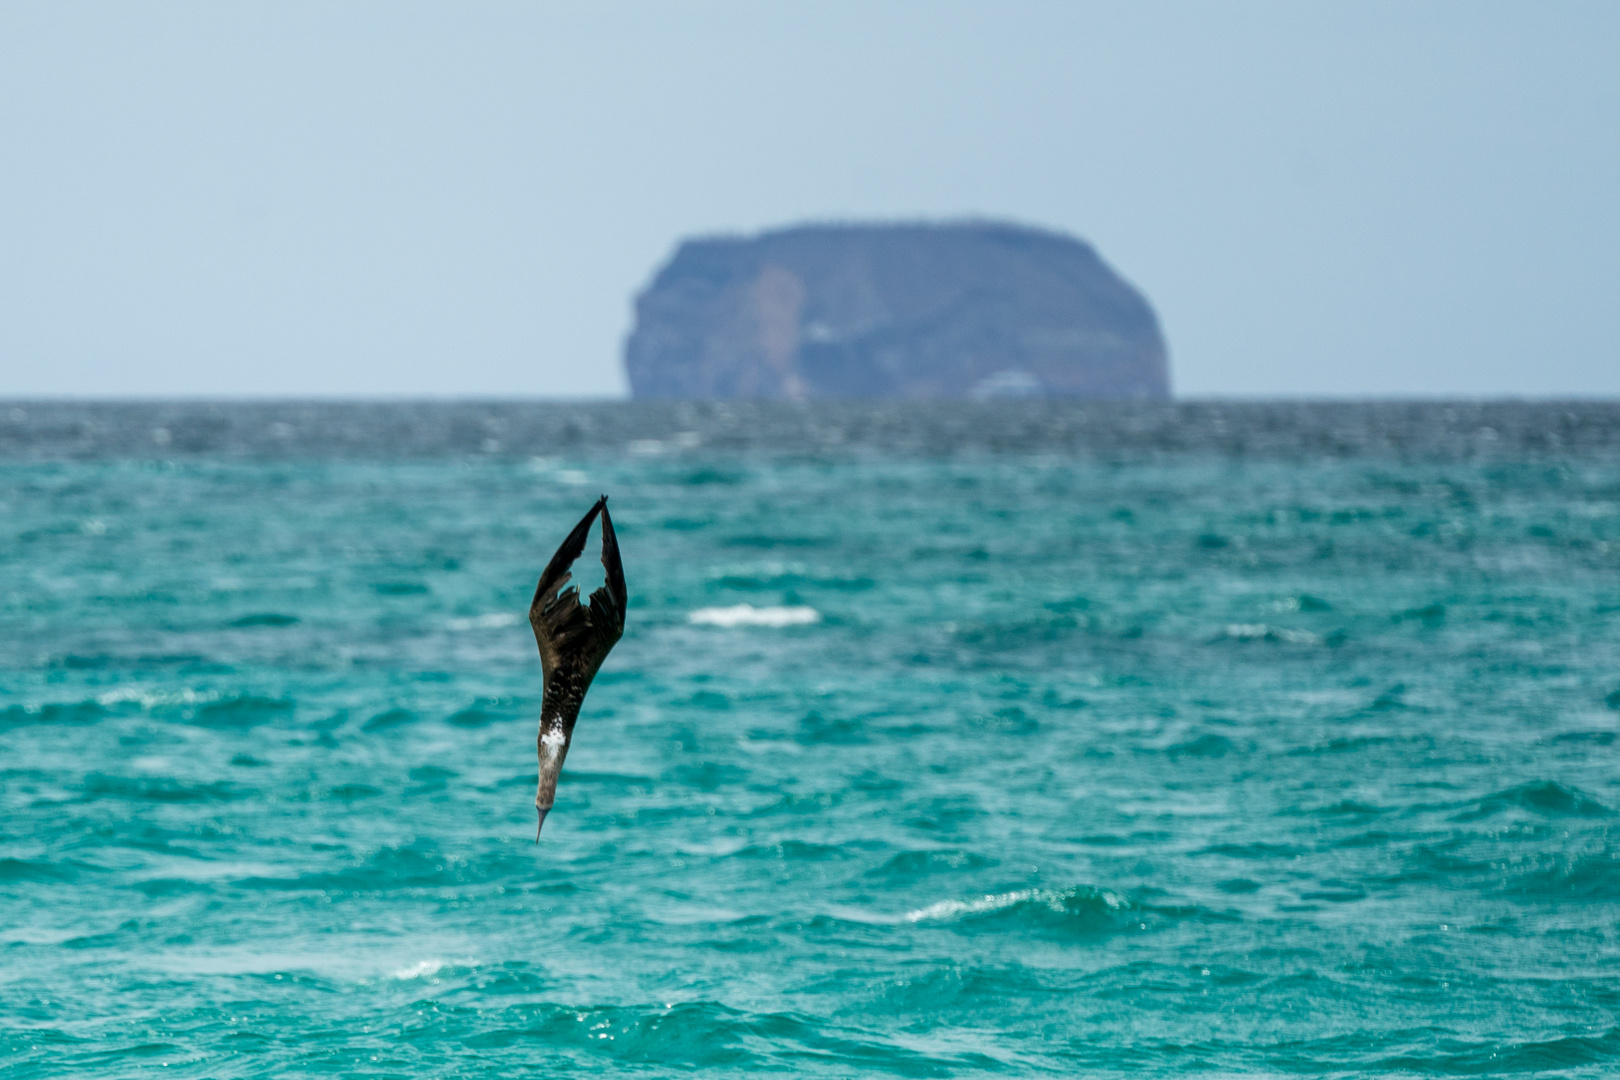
<box><xmin>528</xmin><ymin>495</ymin><xmax>629</xmax><ymax>683</ymax></box>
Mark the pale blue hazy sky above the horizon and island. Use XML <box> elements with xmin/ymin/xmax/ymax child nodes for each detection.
<box><xmin>0</xmin><ymin>0</ymin><xmax>1620</xmax><ymax>397</ymax></box>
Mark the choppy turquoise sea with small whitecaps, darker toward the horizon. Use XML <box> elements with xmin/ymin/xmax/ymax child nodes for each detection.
<box><xmin>0</xmin><ymin>405</ymin><xmax>1620</xmax><ymax>1080</ymax></box>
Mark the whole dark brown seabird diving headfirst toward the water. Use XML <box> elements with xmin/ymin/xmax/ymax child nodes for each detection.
<box><xmin>528</xmin><ymin>495</ymin><xmax>627</xmax><ymax>844</ymax></box>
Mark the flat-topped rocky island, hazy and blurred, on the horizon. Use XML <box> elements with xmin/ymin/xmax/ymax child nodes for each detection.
<box><xmin>625</xmin><ymin>222</ymin><xmax>1170</xmax><ymax>400</ymax></box>
